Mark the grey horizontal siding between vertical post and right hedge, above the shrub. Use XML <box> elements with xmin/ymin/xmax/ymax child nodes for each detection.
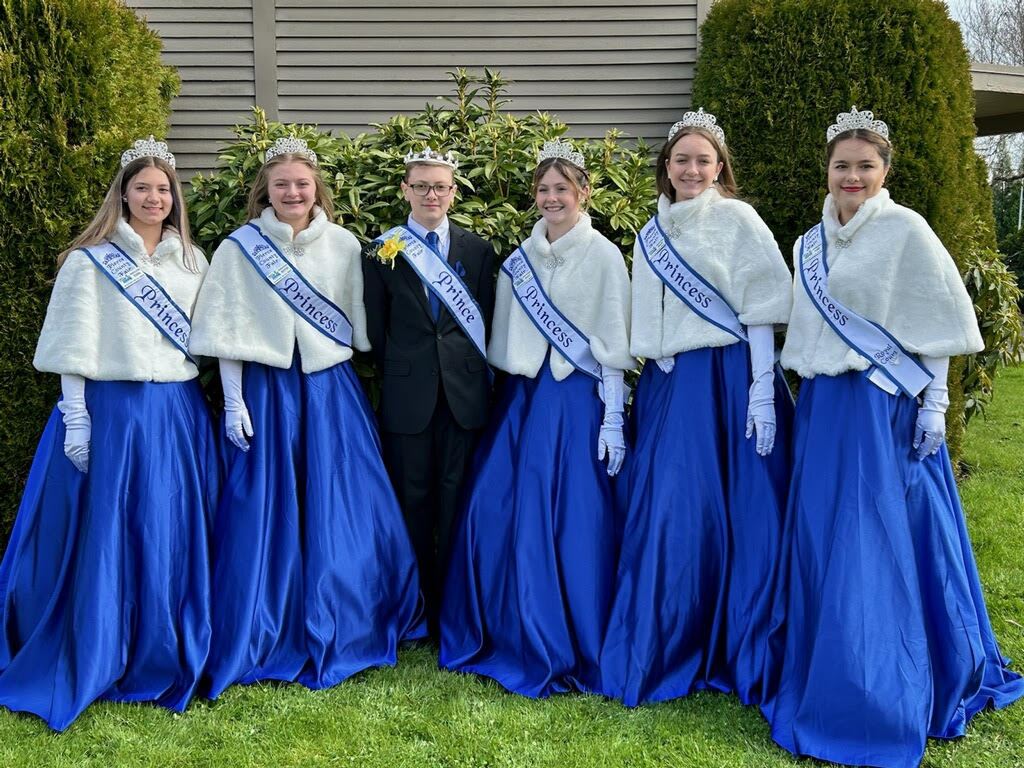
<box><xmin>276</xmin><ymin>0</ymin><xmax>697</xmax><ymax>147</ymax></box>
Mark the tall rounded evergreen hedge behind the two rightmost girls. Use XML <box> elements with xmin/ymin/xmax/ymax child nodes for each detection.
<box><xmin>693</xmin><ymin>0</ymin><xmax>1020</xmax><ymax>466</ymax></box>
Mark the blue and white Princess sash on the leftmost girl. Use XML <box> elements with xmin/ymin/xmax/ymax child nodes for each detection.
<box><xmin>82</xmin><ymin>241</ymin><xmax>196</xmax><ymax>362</ymax></box>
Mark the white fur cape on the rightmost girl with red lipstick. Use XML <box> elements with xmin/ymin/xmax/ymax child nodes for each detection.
<box><xmin>781</xmin><ymin>189</ymin><xmax>984</xmax><ymax>378</ymax></box>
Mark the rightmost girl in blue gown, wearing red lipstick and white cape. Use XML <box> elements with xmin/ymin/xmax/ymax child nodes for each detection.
<box><xmin>762</xmin><ymin>108</ymin><xmax>1024</xmax><ymax>768</ymax></box>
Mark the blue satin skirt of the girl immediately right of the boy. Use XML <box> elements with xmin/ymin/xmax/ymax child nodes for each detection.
<box><xmin>440</xmin><ymin>362</ymin><xmax>614</xmax><ymax>697</ymax></box>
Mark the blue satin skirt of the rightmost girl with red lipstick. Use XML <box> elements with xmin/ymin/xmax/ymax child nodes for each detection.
<box><xmin>762</xmin><ymin>373</ymin><xmax>1024</xmax><ymax>768</ymax></box>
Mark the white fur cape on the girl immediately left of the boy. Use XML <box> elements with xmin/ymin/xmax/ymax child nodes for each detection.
<box><xmin>189</xmin><ymin>208</ymin><xmax>370</xmax><ymax>373</ymax></box>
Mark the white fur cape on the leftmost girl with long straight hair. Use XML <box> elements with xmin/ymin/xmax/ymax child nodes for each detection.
<box><xmin>33</xmin><ymin>220</ymin><xmax>207</xmax><ymax>381</ymax></box>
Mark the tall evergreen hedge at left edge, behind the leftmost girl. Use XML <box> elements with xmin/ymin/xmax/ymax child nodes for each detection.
<box><xmin>0</xmin><ymin>0</ymin><xmax>178</xmax><ymax>549</ymax></box>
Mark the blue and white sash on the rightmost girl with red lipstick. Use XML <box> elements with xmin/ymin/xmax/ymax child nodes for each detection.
<box><xmin>800</xmin><ymin>223</ymin><xmax>934</xmax><ymax>397</ymax></box>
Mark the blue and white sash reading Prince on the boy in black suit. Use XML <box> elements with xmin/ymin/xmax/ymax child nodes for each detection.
<box><xmin>375</xmin><ymin>224</ymin><xmax>487</xmax><ymax>359</ymax></box>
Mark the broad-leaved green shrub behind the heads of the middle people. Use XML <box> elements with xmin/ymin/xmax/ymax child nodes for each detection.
<box><xmin>187</xmin><ymin>70</ymin><xmax>655</xmax><ymax>266</ymax></box>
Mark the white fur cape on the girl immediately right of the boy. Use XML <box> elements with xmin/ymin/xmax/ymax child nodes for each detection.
<box><xmin>487</xmin><ymin>214</ymin><xmax>635</xmax><ymax>381</ymax></box>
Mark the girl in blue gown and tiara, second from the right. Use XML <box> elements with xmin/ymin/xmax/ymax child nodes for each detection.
<box><xmin>601</xmin><ymin>110</ymin><xmax>792</xmax><ymax>707</ymax></box>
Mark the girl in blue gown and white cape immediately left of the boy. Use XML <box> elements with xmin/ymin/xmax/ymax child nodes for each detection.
<box><xmin>191</xmin><ymin>139</ymin><xmax>424</xmax><ymax>697</ymax></box>
